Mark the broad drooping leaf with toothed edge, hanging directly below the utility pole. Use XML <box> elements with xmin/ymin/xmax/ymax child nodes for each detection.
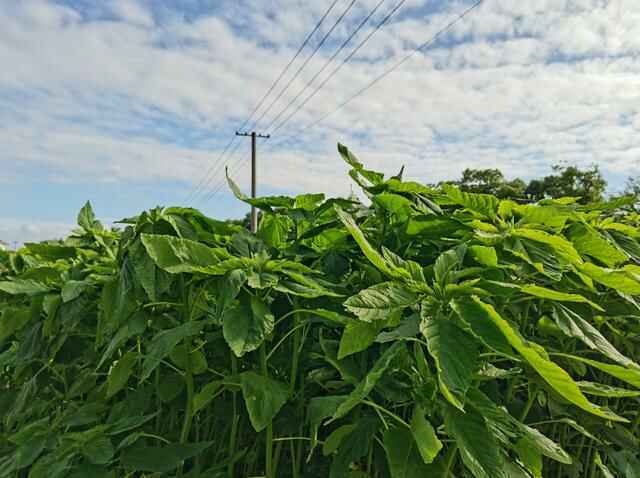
<box><xmin>222</xmin><ymin>296</ymin><xmax>274</xmax><ymax>357</ymax></box>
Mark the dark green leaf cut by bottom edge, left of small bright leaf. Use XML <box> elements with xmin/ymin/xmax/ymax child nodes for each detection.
<box><xmin>383</xmin><ymin>428</ymin><xmax>436</xmax><ymax>478</ymax></box>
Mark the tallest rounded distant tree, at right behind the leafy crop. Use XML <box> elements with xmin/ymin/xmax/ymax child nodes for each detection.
<box><xmin>525</xmin><ymin>165</ymin><xmax>607</xmax><ymax>203</ymax></box>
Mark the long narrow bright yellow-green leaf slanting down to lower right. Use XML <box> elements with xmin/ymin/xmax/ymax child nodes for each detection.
<box><xmin>458</xmin><ymin>297</ymin><xmax>627</xmax><ymax>422</ymax></box>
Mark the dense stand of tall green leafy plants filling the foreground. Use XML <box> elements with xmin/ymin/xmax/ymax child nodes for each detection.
<box><xmin>0</xmin><ymin>146</ymin><xmax>640</xmax><ymax>478</ymax></box>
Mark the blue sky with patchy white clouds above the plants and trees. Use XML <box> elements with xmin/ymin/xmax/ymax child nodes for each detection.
<box><xmin>0</xmin><ymin>0</ymin><xmax>640</xmax><ymax>244</ymax></box>
